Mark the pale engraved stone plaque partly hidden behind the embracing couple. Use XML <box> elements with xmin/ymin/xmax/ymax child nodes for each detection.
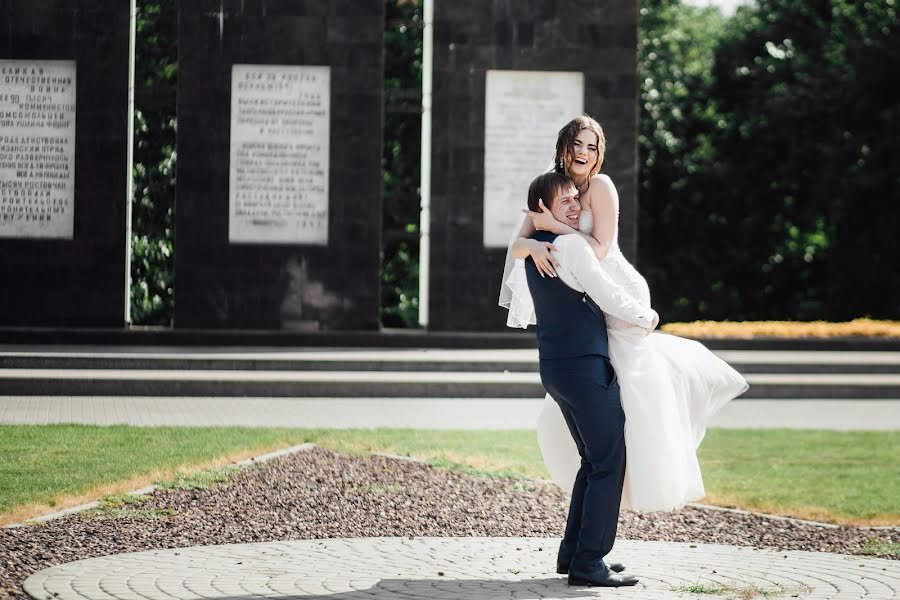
<box><xmin>484</xmin><ymin>70</ymin><xmax>584</xmax><ymax>248</ymax></box>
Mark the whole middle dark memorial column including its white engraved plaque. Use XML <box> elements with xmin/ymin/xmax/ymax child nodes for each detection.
<box><xmin>175</xmin><ymin>0</ymin><xmax>384</xmax><ymax>330</ymax></box>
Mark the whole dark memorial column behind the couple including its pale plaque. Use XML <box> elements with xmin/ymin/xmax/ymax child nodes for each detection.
<box><xmin>429</xmin><ymin>0</ymin><xmax>638</xmax><ymax>331</ymax></box>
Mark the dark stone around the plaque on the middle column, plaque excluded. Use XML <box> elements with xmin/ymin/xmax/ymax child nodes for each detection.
<box><xmin>175</xmin><ymin>0</ymin><xmax>384</xmax><ymax>330</ymax></box>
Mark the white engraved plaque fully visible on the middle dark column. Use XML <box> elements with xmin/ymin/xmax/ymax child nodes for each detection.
<box><xmin>228</xmin><ymin>65</ymin><xmax>331</xmax><ymax>245</ymax></box>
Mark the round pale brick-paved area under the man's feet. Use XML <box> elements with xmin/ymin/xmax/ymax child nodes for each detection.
<box><xmin>24</xmin><ymin>538</ymin><xmax>900</xmax><ymax>600</ymax></box>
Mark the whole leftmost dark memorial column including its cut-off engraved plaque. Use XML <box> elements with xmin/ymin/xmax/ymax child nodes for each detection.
<box><xmin>0</xmin><ymin>0</ymin><xmax>130</xmax><ymax>327</ymax></box>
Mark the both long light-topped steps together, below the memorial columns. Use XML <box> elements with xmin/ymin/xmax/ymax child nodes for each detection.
<box><xmin>0</xmin><ymin>346</ymin><xmax>900</xmax><ymax>399</ymax></box>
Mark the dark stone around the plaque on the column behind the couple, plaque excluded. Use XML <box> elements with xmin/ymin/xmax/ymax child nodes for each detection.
<box><xmin>429</xmin><ymin>0</ymin><xmax>638</xmax><ymax>331</ymax></box>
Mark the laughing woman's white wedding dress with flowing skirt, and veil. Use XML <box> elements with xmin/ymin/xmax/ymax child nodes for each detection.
<box><xmin>501</xmin><ymin>211</ymin><xmax>748</xmax><ymax>512</ymax></box>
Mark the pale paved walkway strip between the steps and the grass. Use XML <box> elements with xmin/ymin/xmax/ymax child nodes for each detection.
<box><xmin>0</xmin><ymin>396</ymin><xmax>900</xmax><ymax>430</ymax></box>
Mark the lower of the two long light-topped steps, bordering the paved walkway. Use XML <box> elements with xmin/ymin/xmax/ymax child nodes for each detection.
<box><xmin>0</xmin><ymin>369</ymin><xmax>900</xmax><ymax>399</ymax></box>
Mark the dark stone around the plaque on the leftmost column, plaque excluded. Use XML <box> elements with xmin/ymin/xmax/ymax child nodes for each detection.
<box><xmin>0</xmin><ymin>0</ymin><xmax>130</xmax><ymax>327</ymax></box>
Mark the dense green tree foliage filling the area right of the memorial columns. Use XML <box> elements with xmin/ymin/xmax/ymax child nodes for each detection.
<box><xmin>640</xmin><ymin>0</ymin><xmax>900</xmax><ymax>320</ymax></box>
